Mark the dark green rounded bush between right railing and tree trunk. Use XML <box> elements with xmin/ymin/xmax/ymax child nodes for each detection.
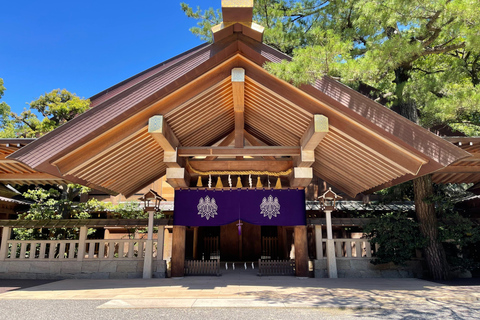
<box><xmin>364</xmin><ymin>212</ymin><xmax>426</xmax><ymax>265</ymax></box>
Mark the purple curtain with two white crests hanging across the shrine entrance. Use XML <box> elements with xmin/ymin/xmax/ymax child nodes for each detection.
<box><xmin>173</xmin><ymin>189</ymin><xmax>306</xmax><ymax>227</ymax></box>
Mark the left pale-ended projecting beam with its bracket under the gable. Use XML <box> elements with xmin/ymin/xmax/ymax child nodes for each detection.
<box><xmin>148</xmin><ymin>115</ymin><xmax>184</xmax><ymax>168</ymax></box>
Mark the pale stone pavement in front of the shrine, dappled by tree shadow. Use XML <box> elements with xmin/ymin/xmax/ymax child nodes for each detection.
<box><xmin>0</xmin><ymin>273</ymin><xmax>480</xmax><ymax>309</ymax></box>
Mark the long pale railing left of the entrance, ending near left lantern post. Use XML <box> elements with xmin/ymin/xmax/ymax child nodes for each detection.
<box><xmin>5</xmin><ymin>239</ymin><xmax>148</xmax><ymax>260</ymax></box>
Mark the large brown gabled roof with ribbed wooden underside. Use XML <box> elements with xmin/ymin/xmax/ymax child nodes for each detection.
<box><xmin>8</xmin><ymin>33</ymin><xmax>468</xmax><ymax>195</ymax></box>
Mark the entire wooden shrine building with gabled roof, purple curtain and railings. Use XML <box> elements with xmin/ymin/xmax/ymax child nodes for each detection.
<box><xmin>0</xmin><ymin>0</ymin><xmax>470</xmax><ymax>277</ymax></box>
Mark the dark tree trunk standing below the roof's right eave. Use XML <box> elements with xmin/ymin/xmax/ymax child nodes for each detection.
<box><xmin>413</xmin><ymin>175</ymin><xmax>449</xmax><ymax>280</ymax></box>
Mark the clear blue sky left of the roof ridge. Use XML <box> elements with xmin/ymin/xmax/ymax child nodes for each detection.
<box><xmin>0</xmin><ymin>0</ymin><xmax>221</xmax><ymax>112</ymax></box>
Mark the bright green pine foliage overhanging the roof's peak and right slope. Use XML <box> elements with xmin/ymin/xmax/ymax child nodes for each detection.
<box><xmin>182</xmin><ymin>0</ymin><xmax>480</xmax><ymax>135</ymax></box>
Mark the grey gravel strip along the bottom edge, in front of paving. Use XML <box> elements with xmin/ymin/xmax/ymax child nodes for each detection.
<box><xmin>0</xmin><ymin>300</ymin><xmax>480</xmax><ymax>320</ymax></box>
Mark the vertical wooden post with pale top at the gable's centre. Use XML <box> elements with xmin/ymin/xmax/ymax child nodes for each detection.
<box><xmin>232</xmin><ymin>68</ymin><xmax>245</xmax><ymax>160</ymax></box>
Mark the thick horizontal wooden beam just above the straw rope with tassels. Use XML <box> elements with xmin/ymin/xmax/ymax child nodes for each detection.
<box><xmin>188</xmin><ymin>159</ymin><xmax>292</xmax><ymax>172</ymax></box>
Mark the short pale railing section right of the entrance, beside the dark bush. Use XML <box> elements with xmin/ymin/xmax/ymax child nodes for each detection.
<box><xmin>318</xmin><ymin>239</ymin><xmax>377</xmax><ymax>259</ymax></box>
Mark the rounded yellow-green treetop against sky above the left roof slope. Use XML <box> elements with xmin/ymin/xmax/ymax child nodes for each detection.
<box><xmin>12</xmin><ymin>89</ymin><xmax>90</xmax><ymax>138</ymax></box>
